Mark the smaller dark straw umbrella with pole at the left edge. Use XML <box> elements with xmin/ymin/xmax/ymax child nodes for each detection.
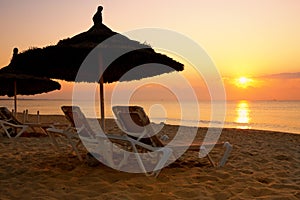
<box><xmin>0</xmin><ymin>67</ymin><xmax>61</xmax><ymax>113</ymax></box>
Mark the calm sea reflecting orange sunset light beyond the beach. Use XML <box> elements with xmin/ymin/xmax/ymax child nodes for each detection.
<box><xmin>0</xmin><ymin>99</ymin><xmax>300</xmax><ymax>134</ymax></box>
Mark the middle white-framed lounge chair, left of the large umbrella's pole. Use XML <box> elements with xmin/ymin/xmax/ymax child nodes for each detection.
<box><xmin>47</xmin><ymin>106</ymin><xmax>171</xmax><ymax>176</ymax></box>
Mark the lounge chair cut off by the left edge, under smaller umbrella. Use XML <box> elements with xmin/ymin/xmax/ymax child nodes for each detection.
<box><xmin>0</xmin><ymin>107</ymin><xmax>54</xmax><ymax>138</ymax></box>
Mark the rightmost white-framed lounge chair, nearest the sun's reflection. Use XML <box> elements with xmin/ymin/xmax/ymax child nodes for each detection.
<box><xmin>112</xmin><ymin>106</ymin><xmax>232</xmax><ymax>167</ymax></box>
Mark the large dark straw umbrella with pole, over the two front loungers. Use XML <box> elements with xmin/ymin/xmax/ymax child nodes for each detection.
<box><xmin>4</xmin><ymin>6</ymin><xmax>184</xmax><ymax>128</ymax></box>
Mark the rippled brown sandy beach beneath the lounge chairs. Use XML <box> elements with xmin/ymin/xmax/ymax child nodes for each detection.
<box><xmin>0</xmin><ymin>116</ymin><xmax>300</xmax><ymax>200</ymax></box>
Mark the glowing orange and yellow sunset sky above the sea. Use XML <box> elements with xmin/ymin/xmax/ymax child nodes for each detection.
<box><xmin>0</xmin><ymin>0</ymin><xmax>300</xmax><ymax>100</ymax></box>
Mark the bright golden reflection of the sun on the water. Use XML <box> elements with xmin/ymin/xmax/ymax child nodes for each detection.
<box><xmin>235</xmin><ymin>101</ymin><xmax>251</xmax><ymax>129</ymax></box>
